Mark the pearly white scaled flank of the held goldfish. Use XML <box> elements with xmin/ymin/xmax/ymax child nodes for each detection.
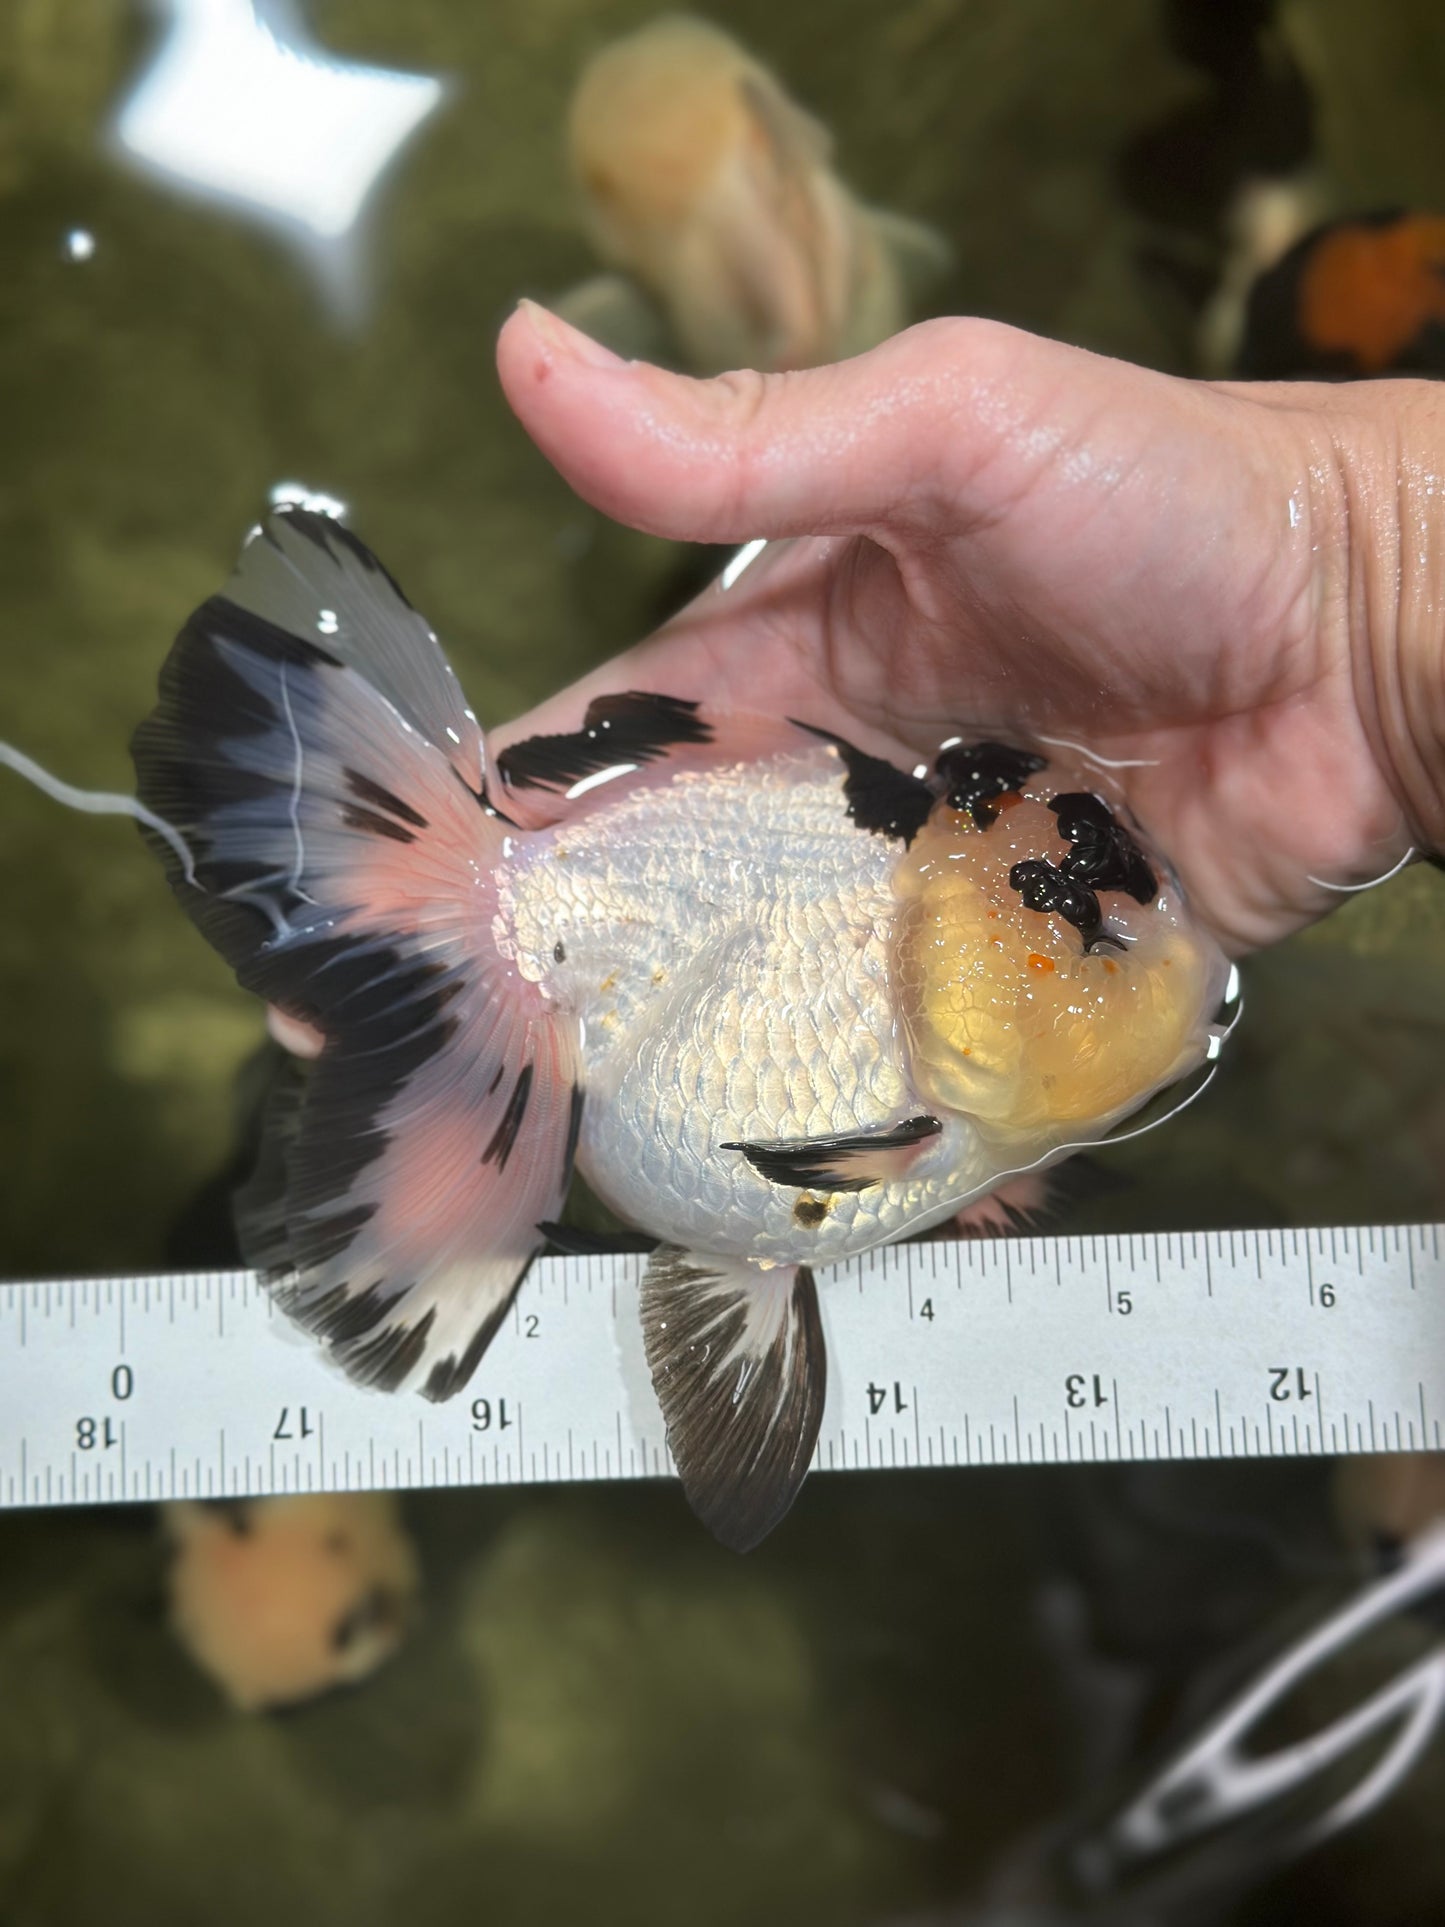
<box><xmin>507</xmin><ymin>748</ymin><xmax>940</xmax><ymax>1258</ymax></box>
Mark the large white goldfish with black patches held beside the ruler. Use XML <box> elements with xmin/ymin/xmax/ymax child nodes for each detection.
<box><xmin>133</xmin><ymin>505</ymin><xmax>1229</xmax><ymax>1547</ymax></box>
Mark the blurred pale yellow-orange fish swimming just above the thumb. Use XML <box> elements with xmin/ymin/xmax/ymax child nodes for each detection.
<box><xmin>565</xmin><ymin>13</ymin><xmax>948</xmax><ymax>374</ymax></box>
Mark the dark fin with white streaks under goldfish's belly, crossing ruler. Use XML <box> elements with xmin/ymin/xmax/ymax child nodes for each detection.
<box><xmin>642</xmin><ymin>1245</ymin><xmax>827</xmax><ymax>1551</ymax></box>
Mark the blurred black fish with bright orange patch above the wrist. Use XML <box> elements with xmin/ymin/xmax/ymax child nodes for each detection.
<box><xmin>1239</xmin><ymin>208</ymin><xmax>1445</xmax><ymax>382</ymax></box>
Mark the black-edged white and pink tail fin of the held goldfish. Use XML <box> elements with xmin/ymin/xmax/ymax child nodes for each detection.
<box><xmin>133</xmin><ymin>509</ymin><xmax>582</xmax><ymax>1399</ymax></box>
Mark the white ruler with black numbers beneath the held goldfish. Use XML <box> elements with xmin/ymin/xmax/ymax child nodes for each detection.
<box><xmin>0</xmin><ymin>1226</ymin><xmax>1445</xmax><ymax>1507</ymax></box>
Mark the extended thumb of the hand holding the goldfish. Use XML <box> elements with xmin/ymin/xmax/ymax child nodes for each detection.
<box><xmin>497</xmin><ymin>301</ymin><xmax>1055</xmax><ymax>541</ymax></box>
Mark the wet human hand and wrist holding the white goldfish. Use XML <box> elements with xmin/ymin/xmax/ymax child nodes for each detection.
<box><xmin>491</xmin><ymin>304</ymin><xmax>1445</xmax><ymax>952</ymax></box>
